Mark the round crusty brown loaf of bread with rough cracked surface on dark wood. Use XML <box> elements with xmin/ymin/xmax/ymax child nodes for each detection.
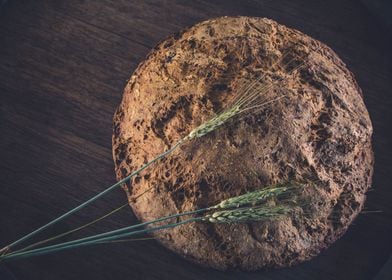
<box><xmin>113</xmin><ymin>17</ymin><xmax>373</xmax><ymax>270</ymax></box>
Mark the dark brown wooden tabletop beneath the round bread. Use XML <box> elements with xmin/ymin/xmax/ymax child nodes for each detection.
<box><xmin>0</xmin><ymin>0</ymin><xmax>392</xmax><ymax>280</ymax></box>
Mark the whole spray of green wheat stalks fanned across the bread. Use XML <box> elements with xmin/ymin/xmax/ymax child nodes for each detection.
<box><xmin>0</xmin><ymin>44</ymin><xmax>316</xmax><ymax>261</ymax></box>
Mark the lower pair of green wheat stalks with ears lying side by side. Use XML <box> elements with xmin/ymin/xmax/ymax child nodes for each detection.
<box><xmin>0</xmin><ymin>182</ymin><xmax>301</xmax><ymax>260</ymax></box>
